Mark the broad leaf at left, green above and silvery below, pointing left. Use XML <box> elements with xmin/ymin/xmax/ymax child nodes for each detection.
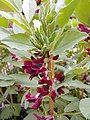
<box><xmin>1</xmin><ymin>33</ymin><xmax>33</xmax><ymax>50</ymax></box>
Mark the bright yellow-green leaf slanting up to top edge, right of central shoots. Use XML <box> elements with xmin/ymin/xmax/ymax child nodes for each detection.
<box><xmin>56</xmin><ymin>0</ymin><xmax>79</xmax><ymax>27</ymax></box>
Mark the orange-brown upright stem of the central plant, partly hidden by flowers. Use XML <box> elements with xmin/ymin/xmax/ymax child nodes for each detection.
<box><xmin>48</xmin><ymin>55</ymin><xmax>54</xmax><ymax>115</ymax></box>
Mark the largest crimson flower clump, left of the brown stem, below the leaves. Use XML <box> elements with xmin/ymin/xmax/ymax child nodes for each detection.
<box><xmin>22</xmin><ymin>57</ymin><xmax>46</xmax><ymax>79</ymax></box>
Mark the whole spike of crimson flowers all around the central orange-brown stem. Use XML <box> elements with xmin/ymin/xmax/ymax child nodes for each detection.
<box><xmin>22</xmin><ymin>52</ymin><xmax>64</xmax><ymax>110</ymax></box>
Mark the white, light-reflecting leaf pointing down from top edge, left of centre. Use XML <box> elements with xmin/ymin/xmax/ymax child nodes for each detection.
<box><xmin>22</xmin><ymin>0</ymin><xmax>36</xmax><ymax>23</ymax></box>
